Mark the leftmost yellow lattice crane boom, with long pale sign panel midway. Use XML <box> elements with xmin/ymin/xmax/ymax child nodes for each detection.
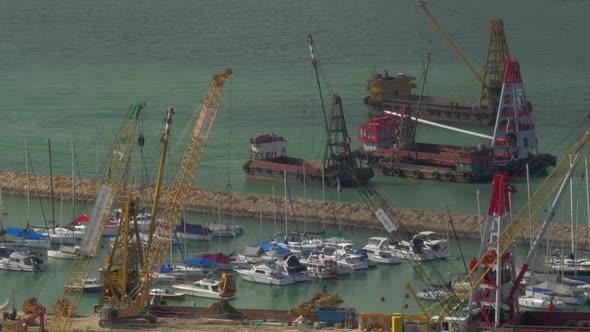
<box><xmin>52</xmin><ymin>102</ymin><xmax>146</xmax><ymax>331</ymax></box>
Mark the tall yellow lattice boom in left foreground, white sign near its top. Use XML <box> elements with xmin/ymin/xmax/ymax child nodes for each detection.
<box><xmin>101</xmin><ymin>68</ymin><xmax>232</xmax><ymax>326</ymax></box>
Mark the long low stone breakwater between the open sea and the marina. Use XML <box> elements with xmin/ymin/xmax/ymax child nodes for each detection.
<box><xmin>0</xmin><ymin>170</ymin><xmax>588</xmax><ymax>248</ymax></box>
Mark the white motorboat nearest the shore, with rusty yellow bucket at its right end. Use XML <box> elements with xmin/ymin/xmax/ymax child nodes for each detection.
<box><xmin>172</xmin><ymin>272</ymin><xmax>236</xmax><ymax>300</ymax></box>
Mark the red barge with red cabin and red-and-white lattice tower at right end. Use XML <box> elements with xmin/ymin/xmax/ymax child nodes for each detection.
<box><xmin>356</xmin><ymin>59</ymin><xmax>556</xmax><ymax>182</ymax></box>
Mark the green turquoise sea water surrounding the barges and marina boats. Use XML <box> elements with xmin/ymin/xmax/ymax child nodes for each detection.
<box><xmin>0</xmin><ymin>0</ymin><xmax>590</xmax><ymax>311</ymax></box>
